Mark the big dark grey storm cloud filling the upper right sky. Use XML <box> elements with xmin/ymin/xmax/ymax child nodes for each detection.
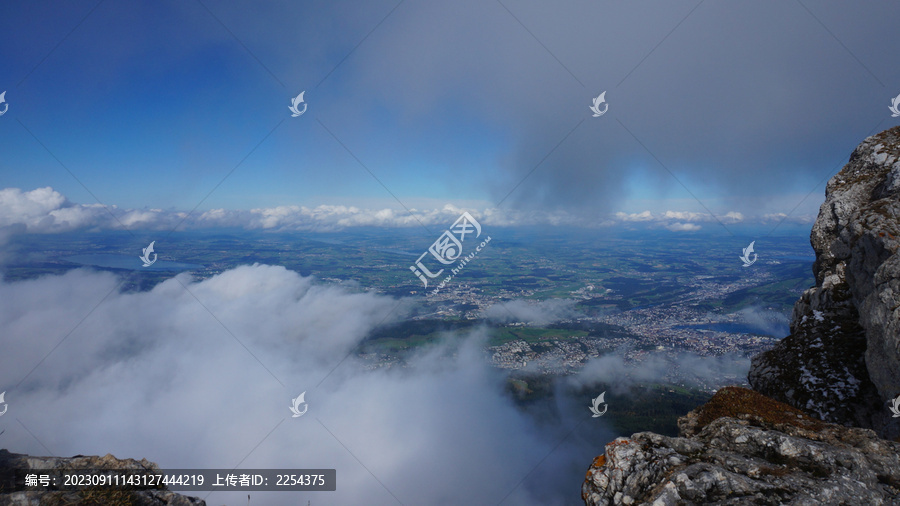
<box><xmin>340</xmin><ymin>1</ymin><xmax>900</xmax><ymax>212</ymax></box>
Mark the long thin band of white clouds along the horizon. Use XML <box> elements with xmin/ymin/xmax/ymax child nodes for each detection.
<box><xmin>0</xmin><ymin>187</ymin><xmax>812</xmax><ymax>233</ymax></box>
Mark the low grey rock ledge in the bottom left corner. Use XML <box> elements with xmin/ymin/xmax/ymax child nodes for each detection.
<box><xmin>0</xmin><ymin>450</ymin><xmax>206</xmax><ymax>506</ymax></box>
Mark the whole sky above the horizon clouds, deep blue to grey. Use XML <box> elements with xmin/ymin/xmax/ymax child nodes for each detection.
<box><xmin>0</xmin><ymin>0</ymin><xmax>900</xmax><ymax>231</ymax></box>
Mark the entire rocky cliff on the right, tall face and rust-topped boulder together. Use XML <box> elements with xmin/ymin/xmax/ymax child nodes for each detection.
<box><xmin>582</xmin><ymin>127</ymin><xmax>900</xmax><ymax>506</ymax></box>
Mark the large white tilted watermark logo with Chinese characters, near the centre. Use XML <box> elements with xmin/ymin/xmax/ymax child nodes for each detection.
<box><xmin>409</xmin><ymin>212</ymin><xmax>491</xmax><ymax>293</ymax></box>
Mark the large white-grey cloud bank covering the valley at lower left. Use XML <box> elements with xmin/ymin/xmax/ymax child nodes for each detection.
<box><xmin>0</xmin><ymin>265</ymin><xmax>605</xmax><ymax>505</ymax></box>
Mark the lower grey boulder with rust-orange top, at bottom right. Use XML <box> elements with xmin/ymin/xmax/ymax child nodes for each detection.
<box><xmin>582</xmin><ymin>387</ymin><xmax>900</xmax><ymax>506</ymax></box>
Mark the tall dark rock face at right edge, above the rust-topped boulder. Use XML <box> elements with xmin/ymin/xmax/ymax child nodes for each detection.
<box><xmin>748</xmin><ymin>127</ymin><xmax>900</xmax><ymax>439</ymax></box>
